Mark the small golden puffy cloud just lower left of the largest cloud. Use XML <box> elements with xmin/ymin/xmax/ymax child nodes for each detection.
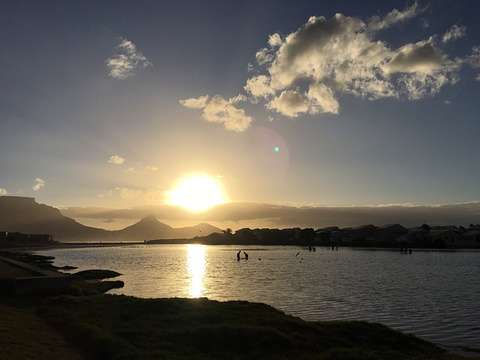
<box><xmin>180</xmin><ymin>95</ymin><xmax>253</xmax><ymax>132</ymax></box>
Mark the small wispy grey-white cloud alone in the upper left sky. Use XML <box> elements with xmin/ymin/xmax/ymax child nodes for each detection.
<box><xmin>106</xmin><ymin>38</ymin><xmax>152</xmax><ymax>79</ymax></box>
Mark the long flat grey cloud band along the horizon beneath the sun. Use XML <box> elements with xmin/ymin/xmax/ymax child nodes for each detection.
<box><xmin>61</xmin><ymin>201</ymin><xmax>480</xmax><ymax>229</ymax></box>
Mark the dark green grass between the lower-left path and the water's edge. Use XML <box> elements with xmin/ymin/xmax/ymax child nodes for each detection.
<box><xmin>35</xmin><ymin>295</ymin><xmax>466</xmax><ymax>360</ymax></box>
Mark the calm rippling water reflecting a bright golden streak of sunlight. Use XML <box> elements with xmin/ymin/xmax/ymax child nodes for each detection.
<box><xmin>41</xmin><ymin>245</ymin><xmax>480</xmax><ymax>348</ymax></box>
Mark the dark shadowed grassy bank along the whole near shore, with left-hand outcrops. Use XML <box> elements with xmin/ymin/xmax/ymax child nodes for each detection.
<box><xmin>0</xmin><ymin>252</ymin><xmax>472</xmax><ymax>360</ymax></box>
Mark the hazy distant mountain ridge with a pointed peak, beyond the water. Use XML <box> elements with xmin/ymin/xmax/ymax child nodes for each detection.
<box><xmin>0</xmin><ymin>196</ymin><xmax>221</xmax><ymax>242</ymax></box>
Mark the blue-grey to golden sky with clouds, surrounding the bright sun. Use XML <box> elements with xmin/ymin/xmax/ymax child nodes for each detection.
<box><xmin>0</xmin><ymin>0</ymin><xmax>480</xmax><ymax>229</ymax></box>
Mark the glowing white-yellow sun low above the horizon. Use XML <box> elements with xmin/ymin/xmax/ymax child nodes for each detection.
<box><xmin>169</xmin><ymin>175</ymin><xmax>225</xmax><ymax>211</ymax></box>
